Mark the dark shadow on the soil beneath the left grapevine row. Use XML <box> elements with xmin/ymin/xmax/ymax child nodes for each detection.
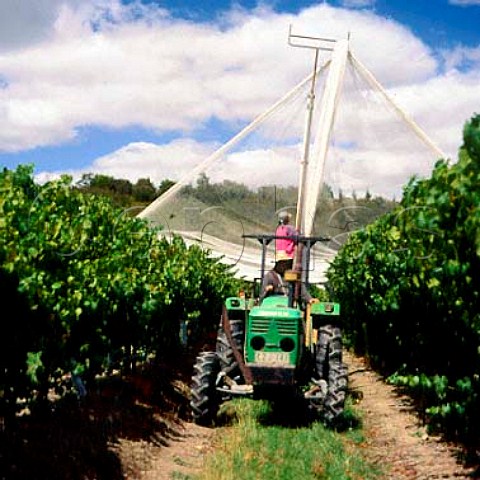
<box><xmin>0</xmin><ymin>352</ymin><xmax>193</xmax><ymax>480</ymax></box>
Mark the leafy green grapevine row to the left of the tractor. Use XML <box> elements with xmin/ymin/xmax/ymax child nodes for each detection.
<box><xmin>0</xmin><ymin>166</ymin><xmax>240</xmax><ymax>416</ymax></box>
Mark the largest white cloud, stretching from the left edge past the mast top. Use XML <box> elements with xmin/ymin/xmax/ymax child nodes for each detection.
<box><xmin>0</xmin><ymin>0</ymin><xmax>436</xmax><ymax>151</ymax></box>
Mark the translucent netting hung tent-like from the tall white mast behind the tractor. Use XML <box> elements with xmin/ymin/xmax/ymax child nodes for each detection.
<box><xmin>140</xmin><ymin>48</ymin><xmax>439</xmax><ymax>282</ymax></box>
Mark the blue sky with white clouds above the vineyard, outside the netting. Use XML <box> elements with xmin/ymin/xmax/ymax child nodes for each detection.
<box><xmin>0</xmin><ymin>0</ymin><xmax>480</xmax><ymax>191</ymax></box>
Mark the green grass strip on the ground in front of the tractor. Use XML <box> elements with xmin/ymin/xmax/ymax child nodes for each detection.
<box><xmin>196</xmin><ymin>399</ymin><xmax>380</xmax><ymax>480</ymax></box>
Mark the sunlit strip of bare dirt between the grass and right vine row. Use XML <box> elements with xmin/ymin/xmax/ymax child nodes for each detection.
<box><xmin>346</xmin><ymin>353</ymin><xmax>480</xmax><ymax>480</ymax></box>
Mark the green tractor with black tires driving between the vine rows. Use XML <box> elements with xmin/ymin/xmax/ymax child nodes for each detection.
<box><xmin>190</xmin><ymin>235</ymin><xmax>347</xmax><ymax>425</ymax></box>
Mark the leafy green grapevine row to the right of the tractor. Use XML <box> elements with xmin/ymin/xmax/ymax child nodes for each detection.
<box><xmin>328</xmin><ymin>115</ymin><xmax>480</xmax><ymax>439</ymax></box>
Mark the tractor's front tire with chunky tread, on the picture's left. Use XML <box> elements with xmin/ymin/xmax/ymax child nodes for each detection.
<box><xmin>190</xmin><ymin>352</ymin><xmax>220</xmax><ymax>426</ymax></box>
